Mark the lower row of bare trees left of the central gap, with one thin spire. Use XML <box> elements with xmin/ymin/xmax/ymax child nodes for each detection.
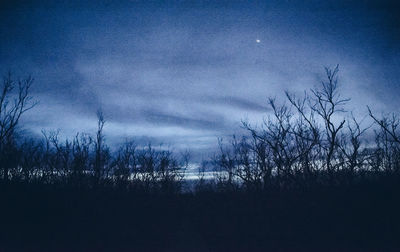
<box><xmin>2</xmin><ymin>112</ymin><xmax>189</xmax><ymax>193</ymax></box>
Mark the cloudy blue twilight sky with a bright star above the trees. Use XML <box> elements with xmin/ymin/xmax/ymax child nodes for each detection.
<box><xmin>0</xmin><ymin>0</ymin><xmax>400</xmax><ymax>159</ymax></box>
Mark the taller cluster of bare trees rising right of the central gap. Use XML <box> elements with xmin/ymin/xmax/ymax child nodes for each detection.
<box><xmin>209</xmin><ymin>67</ymin><xmax>400</xmax><ymax>190</ymax></box>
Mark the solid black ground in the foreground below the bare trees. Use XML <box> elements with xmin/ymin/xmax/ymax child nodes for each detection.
<box><xmin>0</xmin><ymin>180</ymin><xmax>400</xmax><ymax>251</ymax></box>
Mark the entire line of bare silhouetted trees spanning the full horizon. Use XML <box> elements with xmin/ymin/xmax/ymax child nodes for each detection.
<box><xmin>0</xmin><ymin>67</ymin><xmax>400</xmax><ymax>194</ymax></box>
